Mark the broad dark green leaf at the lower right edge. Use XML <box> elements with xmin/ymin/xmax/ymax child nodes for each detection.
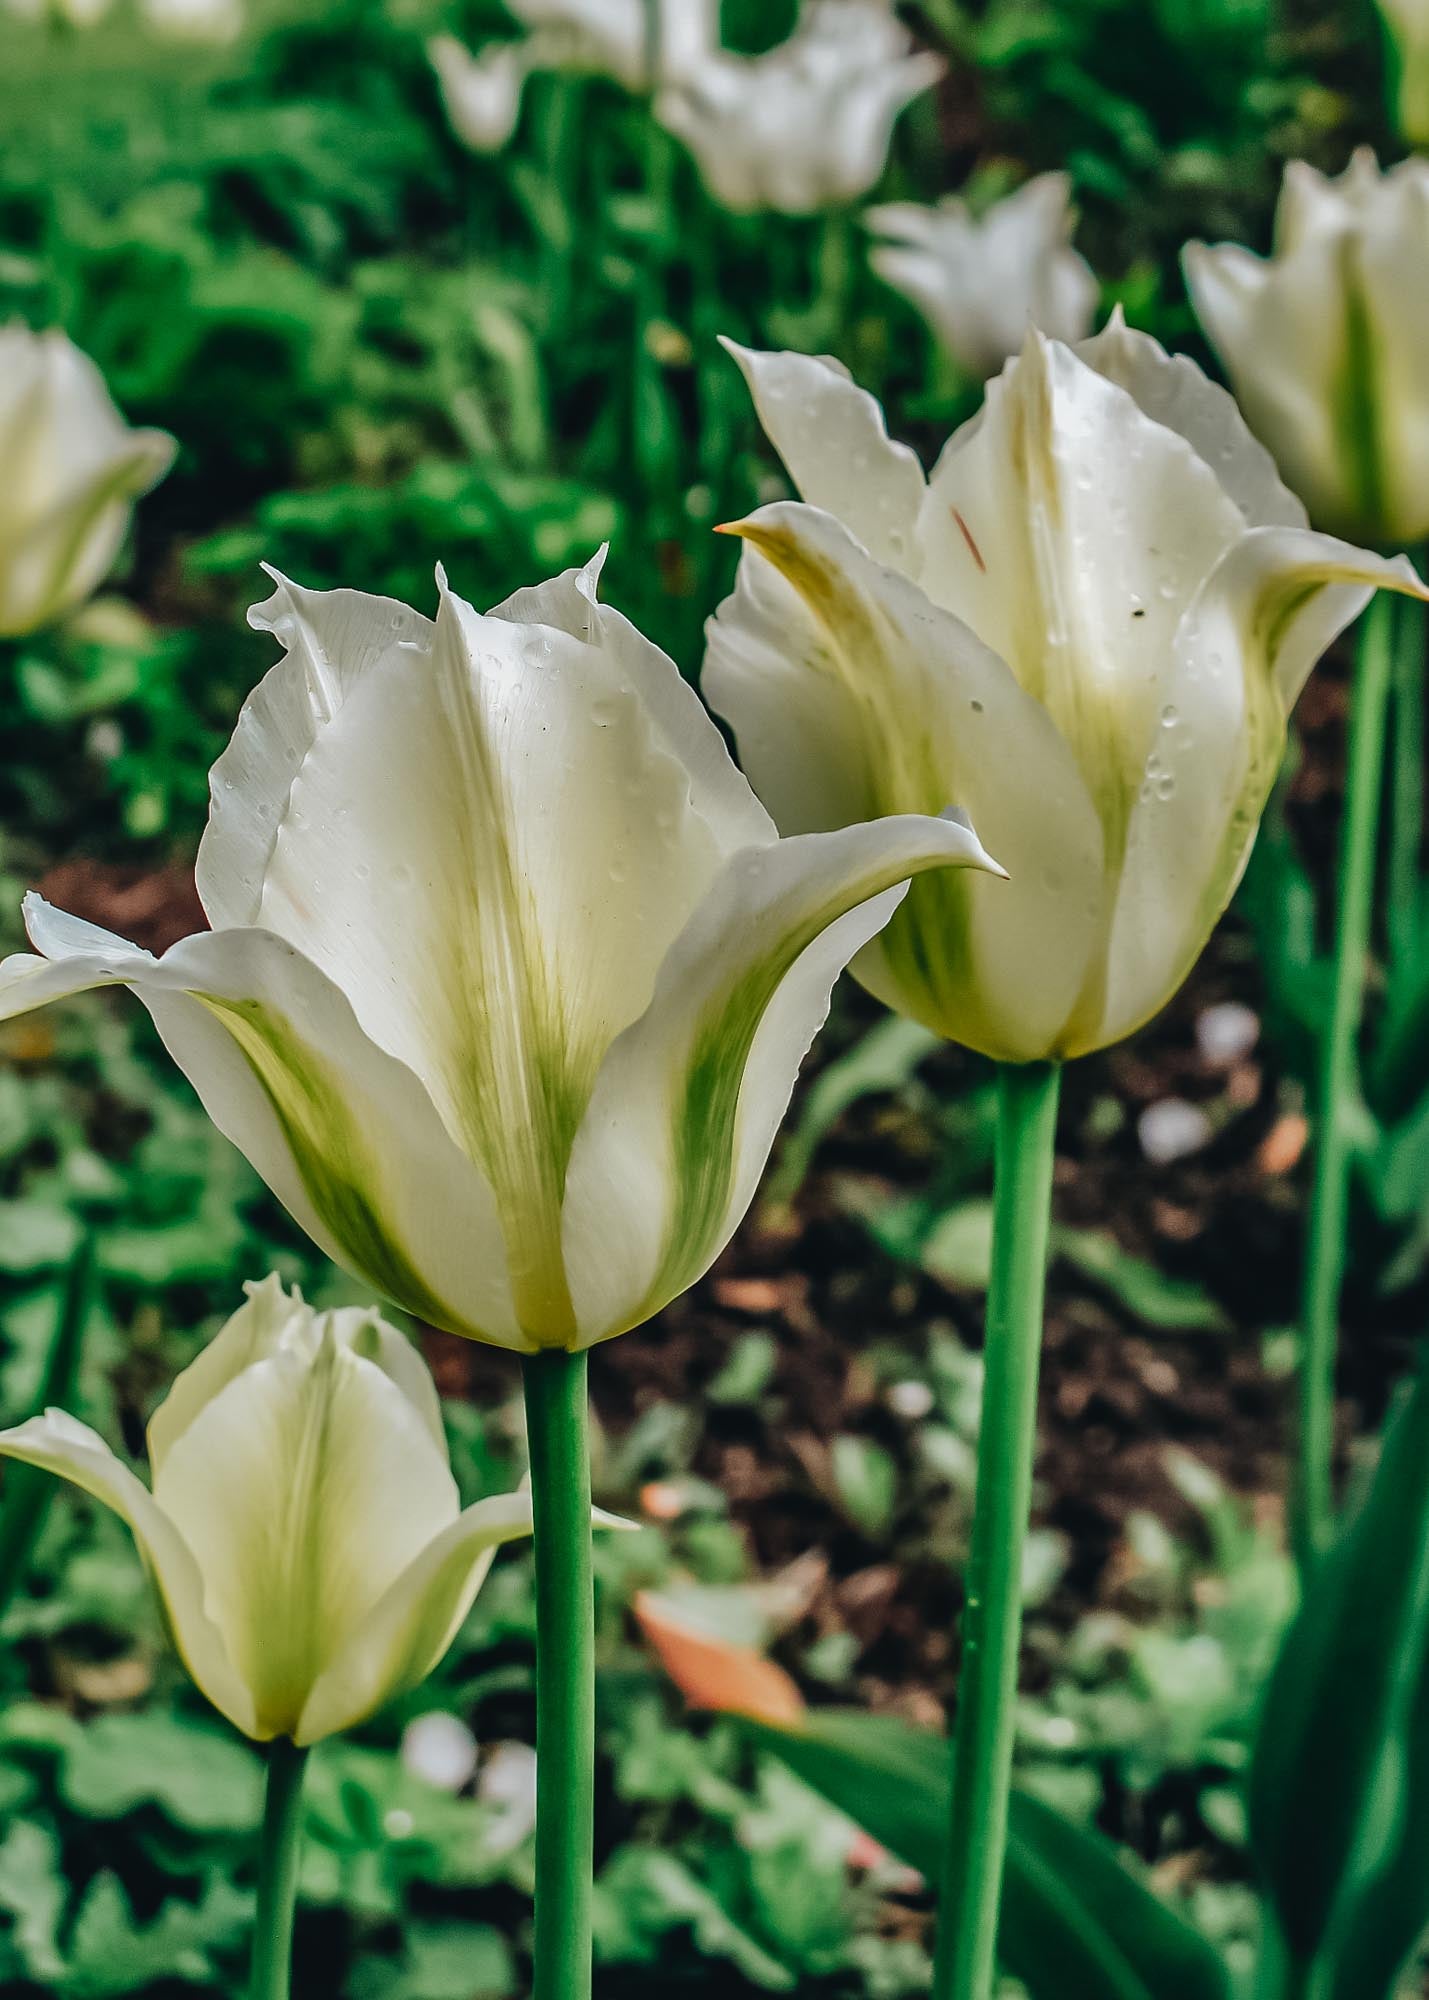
<box><xmin>1249</xmin><ymin>1364</ymin><xmax>1429</xmax><ymax>1976</ymax></box>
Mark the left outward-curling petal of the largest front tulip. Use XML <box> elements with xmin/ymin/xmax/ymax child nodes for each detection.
<box><xmin>0</xmin><ymin>896</ymin><xmax>524</xmax><ymax>1346</ymax></box>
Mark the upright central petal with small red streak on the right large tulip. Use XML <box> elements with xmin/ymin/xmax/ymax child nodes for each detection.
<box><xmin>921</xmin><ymin>334</ymin><xmax>1245</xmax><ymax>874</ymax></box>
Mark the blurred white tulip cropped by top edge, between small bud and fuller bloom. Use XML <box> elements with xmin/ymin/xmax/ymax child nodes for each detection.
<box><xmin>508</xmin><ymin>0</ymin><xmax>719</xmax><ymax>90</ymax></box>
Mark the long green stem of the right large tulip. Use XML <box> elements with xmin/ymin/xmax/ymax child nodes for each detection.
<box><xmin>933</xmin><ymin>1062</ymin><xmax>1061</xmax><ymax>2000</ymax></box>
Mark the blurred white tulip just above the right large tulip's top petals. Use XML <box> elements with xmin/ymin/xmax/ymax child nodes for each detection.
<box><xmin>865</xmin><ymin>174</ymin><xmax>1097</xmax><ymax>380</ymax></box>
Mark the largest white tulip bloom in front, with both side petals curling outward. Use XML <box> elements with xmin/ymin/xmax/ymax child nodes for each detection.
<box><xmin>0</xmin><ymin>558</ymin><xmax>995</xmax><ymax>1352</ymax></box>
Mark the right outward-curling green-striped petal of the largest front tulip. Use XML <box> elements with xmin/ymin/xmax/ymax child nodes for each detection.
<box><xmin>564</xmin><ymin>814</ymin><xmax>995</xmax><ymax>1344</ymax></box>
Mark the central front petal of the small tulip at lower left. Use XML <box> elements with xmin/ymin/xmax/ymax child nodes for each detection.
<box><xmin>154</xmin><ymin>1316</ymin><xmax>458</xmax><ymax>1736</ymax></box>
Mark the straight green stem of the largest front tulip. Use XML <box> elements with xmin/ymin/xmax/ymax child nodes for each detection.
<box><xmin>524</xmin><ymin>1348</ymin><xmax>594</xmax><ymax>2000</ymax></box>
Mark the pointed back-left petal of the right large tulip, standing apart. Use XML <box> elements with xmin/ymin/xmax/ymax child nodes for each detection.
<box><xmin>721</xmin><ymin>340</ymin><xmax>925</xmax><ymax>564</ymax></box>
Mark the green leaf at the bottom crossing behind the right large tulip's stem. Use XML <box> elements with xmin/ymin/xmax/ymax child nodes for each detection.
<box><xmin>741</xmin><ymin>1710</ymin><xmax>1231</xmax><ymax>2000</ymax></box>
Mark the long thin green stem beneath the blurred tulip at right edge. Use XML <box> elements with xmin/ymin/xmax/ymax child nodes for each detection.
<box><xmin>1291</xmin><ymin>594</ymin><xmax>1395</xmax><ymax>1574</ymax></box>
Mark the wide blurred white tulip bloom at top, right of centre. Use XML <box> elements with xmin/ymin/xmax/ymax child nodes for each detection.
<box><xmin>654</xmin><ymin>0</ymin><xmax>943</xmax><ymax>214</ymax></box>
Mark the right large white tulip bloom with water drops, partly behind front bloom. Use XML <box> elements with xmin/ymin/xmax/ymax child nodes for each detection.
<box><xmin>704</xmin><ymin>316</ymin><xmax>1425</xmax><ymax>1062</ymax></box>
